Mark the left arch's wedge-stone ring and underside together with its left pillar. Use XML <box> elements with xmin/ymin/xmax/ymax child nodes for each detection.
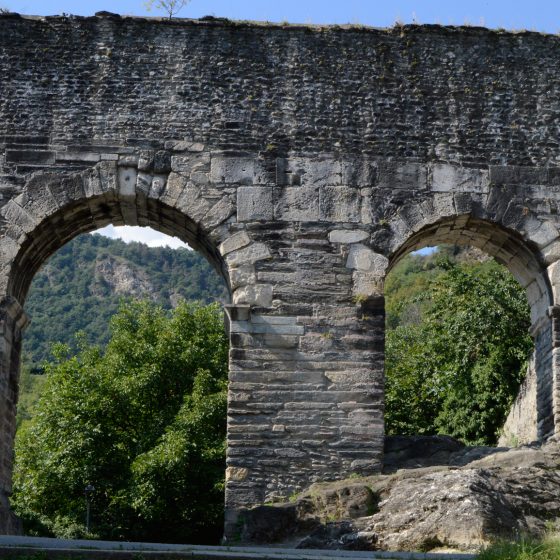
<box><xmin>0</xmin><ymin>156</ymin><xmax>266</xmax><ymax>534</ymax></box>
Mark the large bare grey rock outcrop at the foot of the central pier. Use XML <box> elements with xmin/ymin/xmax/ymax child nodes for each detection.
<box><xmin>238</xmin><ymin>436</ymin><xmax>560</xmax><ymax>551</ymax></box>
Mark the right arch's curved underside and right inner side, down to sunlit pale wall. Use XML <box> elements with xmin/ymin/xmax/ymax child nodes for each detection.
<box><xmin>386</xmin><ymin>214</ymin><xmax>556</xmax><ymax>444</ymax></box>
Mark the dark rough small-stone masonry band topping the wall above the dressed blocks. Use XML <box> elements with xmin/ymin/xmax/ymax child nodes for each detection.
<box><xmin>0</xmin><ymin>15</ymin><xmax>560</xmax><ymax>165</ymax></box>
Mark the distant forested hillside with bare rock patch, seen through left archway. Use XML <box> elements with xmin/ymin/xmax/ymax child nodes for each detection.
<box><xmin>24</xmin><ymin>234</ymin><xmax>227</xmax><ymax>369</ymax></box>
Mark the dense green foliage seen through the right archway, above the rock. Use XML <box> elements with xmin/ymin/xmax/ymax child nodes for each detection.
<box><xmin>386</xmin><ymin>250</ymin><xmax>532</xmax><ymax>445</ymax></box>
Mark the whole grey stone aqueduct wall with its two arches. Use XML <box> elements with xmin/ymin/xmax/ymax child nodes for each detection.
<box><xmin>0</xmin><ymin>13</ymin><xmax>560</xmax><ymax>532</ymax></box>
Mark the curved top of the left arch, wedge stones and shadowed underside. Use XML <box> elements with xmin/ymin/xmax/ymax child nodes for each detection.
<box><xmin>1</xmin><ymin>163</ymin><xmax>231</xmax><ymax>305</ymax></box>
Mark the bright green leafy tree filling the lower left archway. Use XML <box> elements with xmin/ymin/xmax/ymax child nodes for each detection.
<box><xmin>12</xmin><ymin>302</ymin><xmax>227</xmax><ymax>542</ymax></box>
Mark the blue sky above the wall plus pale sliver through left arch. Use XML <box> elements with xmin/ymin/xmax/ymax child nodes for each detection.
<box><xmin>5</xmin><ymin>0</ymin><xmax>560</xmax><ymax>246</ymax></box>
